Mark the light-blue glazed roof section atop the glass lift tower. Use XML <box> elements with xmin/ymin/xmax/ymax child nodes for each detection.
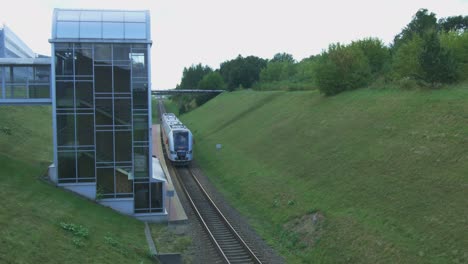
<box><xmin>51</xmin><ymin>9</ymin><xmax>151</xmax><ymax>43</ymax></box>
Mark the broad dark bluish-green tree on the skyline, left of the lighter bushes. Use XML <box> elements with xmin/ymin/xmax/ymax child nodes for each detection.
<box><xmin>219</xmin><ymin>55</ymin><xmax>267</xmax><ymax>91</ymax></box>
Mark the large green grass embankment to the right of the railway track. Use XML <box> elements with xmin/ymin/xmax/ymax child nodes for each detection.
<box><xmin>182</xmin><ymin>85</ymin><xmax>468</xmax><ymax>263</ymax></box>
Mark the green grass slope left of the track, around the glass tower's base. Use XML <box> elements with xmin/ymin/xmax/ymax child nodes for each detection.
<box><xmin>0</xmin><ymin>106</ymin><xmax>151</xmax><ymax>263</ymax></box>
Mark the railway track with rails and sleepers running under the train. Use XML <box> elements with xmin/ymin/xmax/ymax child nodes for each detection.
<box><xmin>159</xmin><ymin>101</ymin><xmax>262</xmax><ymax>263</ymax></box>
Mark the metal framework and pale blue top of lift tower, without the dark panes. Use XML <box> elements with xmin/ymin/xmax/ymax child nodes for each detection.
<box><xmin>49</xmin><ymin>9</ymin><xmax>166</xmax><ymax>215</ymax></box>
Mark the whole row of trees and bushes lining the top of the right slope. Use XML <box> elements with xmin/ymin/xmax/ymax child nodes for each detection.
<box><xmin>178</xmin><ymin>9</ymin><xmax>468</xmax><ymax>98</ymax></box>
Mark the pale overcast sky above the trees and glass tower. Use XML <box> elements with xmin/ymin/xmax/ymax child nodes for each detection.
<box><xmin>0</xmin><ymin>0</ymin><xmax>468</xmax><ymax>90</ymax></box>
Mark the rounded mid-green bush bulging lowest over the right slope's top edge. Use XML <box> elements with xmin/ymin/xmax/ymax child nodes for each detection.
<box><xmin>316</xmin><ymin>43</ymin><xmax>371</xmax><ymax>95</ymax></box>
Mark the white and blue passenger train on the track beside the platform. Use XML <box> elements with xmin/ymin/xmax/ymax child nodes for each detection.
<box><xmin>161</xmin><ymin>113</ymin><xmax>193</xmax><ymax>165</ymax></box>
